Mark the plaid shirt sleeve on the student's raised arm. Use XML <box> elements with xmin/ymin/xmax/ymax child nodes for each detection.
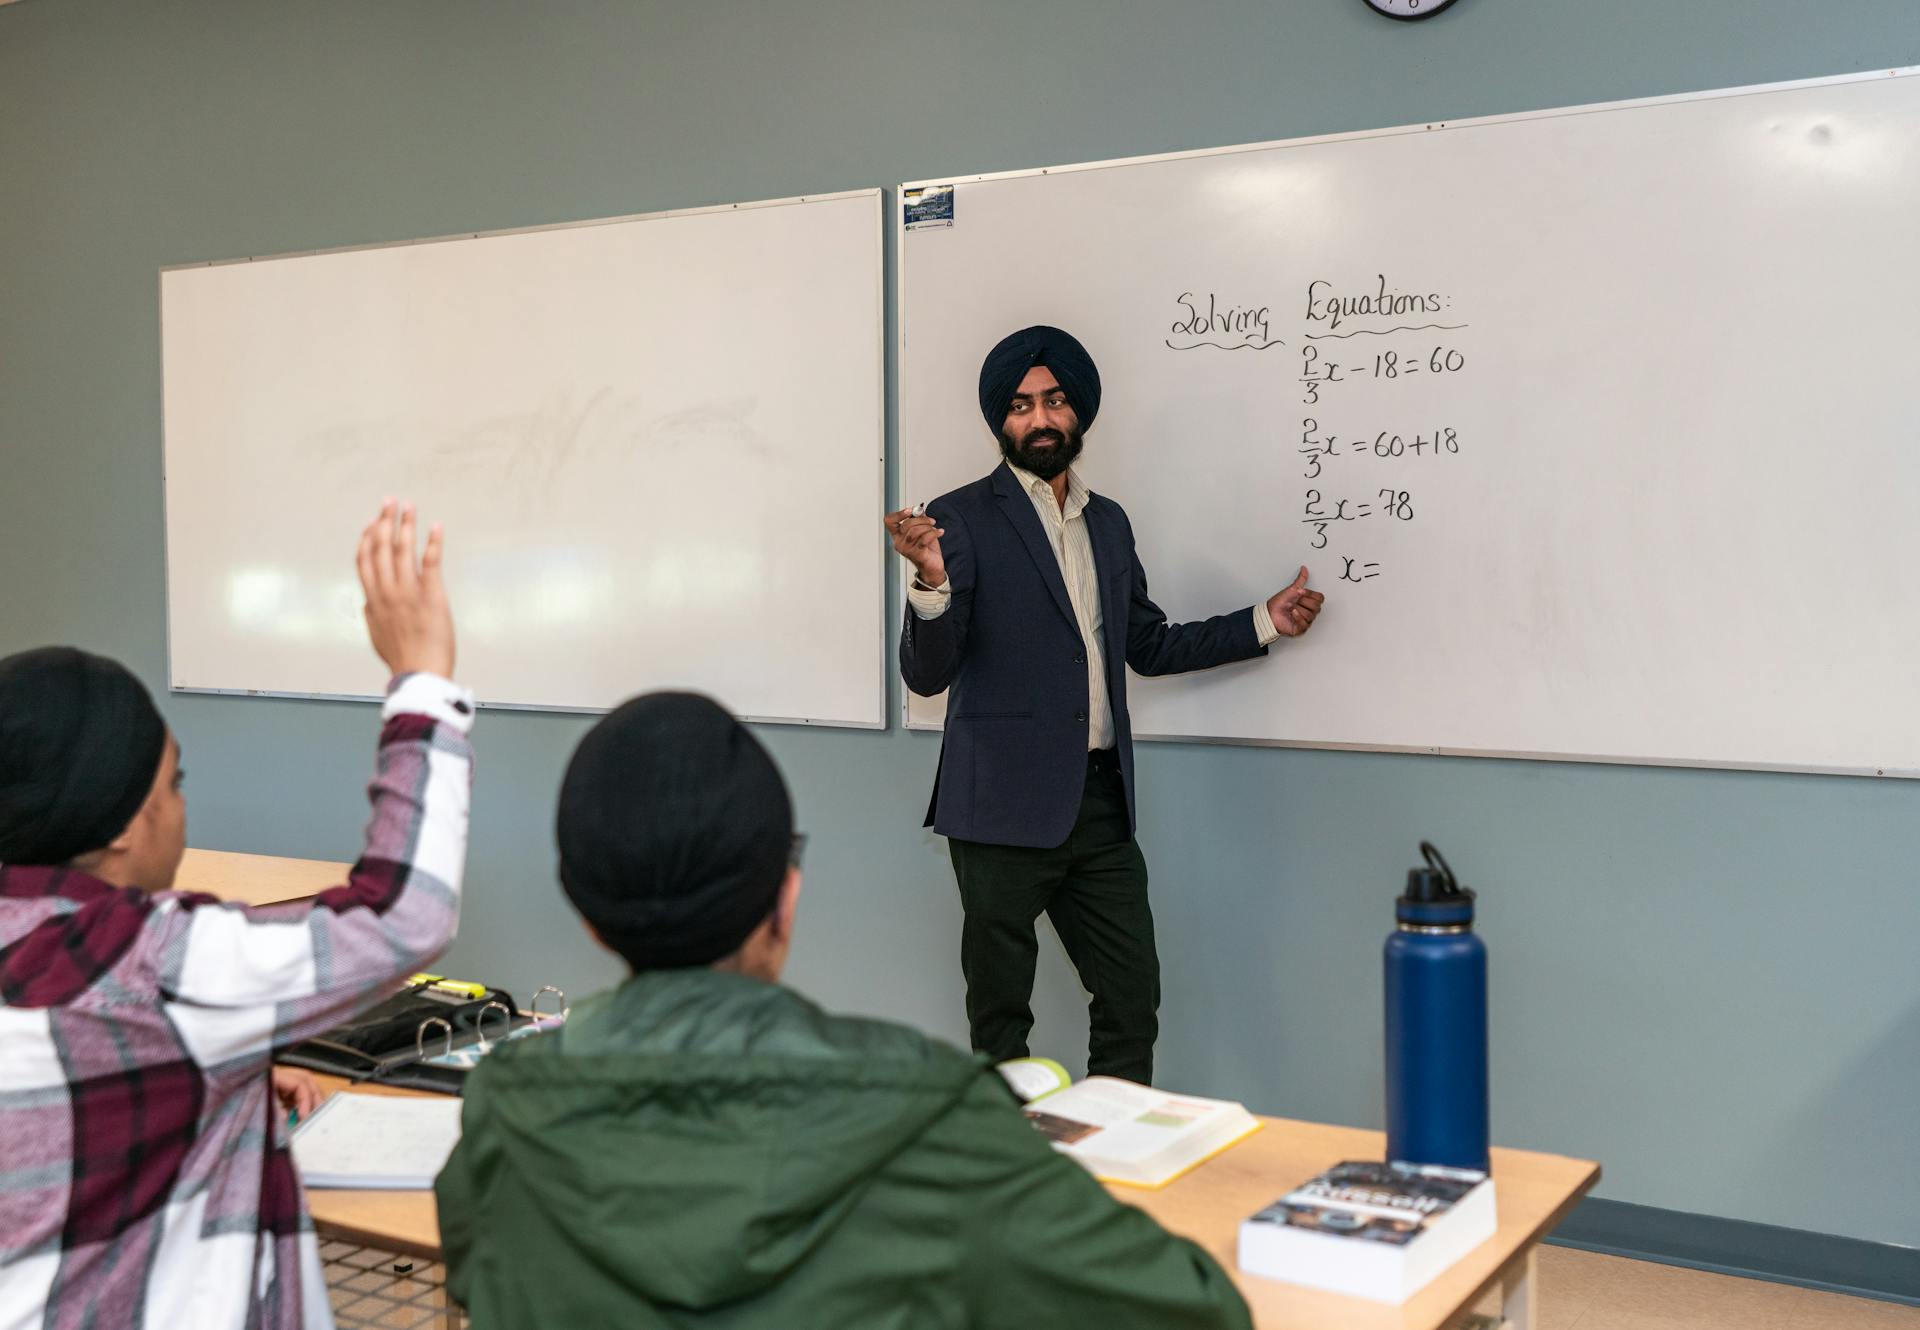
<box><xmin>150</xmin><ymin>674</ymin><xmax>472</xmax><ymax>1067</ymax></box>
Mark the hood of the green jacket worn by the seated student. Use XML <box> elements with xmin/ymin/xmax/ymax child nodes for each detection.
<box><xmin>461</xmin><ymin>969</ymin><xmax>981</xmax><ymax>1309</ymax></box>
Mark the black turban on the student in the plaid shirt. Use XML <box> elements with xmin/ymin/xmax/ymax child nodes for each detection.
<box><xmin>0</xmin><ymin>647</ymin><xmax>167</xmax><ymax>864</ymax></box>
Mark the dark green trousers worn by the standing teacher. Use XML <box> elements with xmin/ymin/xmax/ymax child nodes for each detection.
<box><xmin>947</xmin><ymin>754</ymin><xmax>1160</xmax><ymax>1084</ymax></box>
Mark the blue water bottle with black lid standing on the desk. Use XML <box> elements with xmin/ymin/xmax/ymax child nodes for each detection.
<box><xmin>1386</xmin><ymin>841</ymin><xmax>1488</xmax><ymax>1171</ymax></box>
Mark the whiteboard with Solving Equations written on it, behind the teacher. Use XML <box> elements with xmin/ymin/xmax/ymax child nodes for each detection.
<box><xmin>895</xmin><ymin>69</ymin><xmax>1920</xmax><ymax>777</ymax></box>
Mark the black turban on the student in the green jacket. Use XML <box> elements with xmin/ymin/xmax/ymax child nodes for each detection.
<box><xmin>557</xmin><ymin>693</ymin><xmax>793</xmax><ymax>971</ymax></box>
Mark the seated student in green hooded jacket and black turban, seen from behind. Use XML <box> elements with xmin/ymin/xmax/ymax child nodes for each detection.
<box><xmin>436</xmin><ymin>693</ymin><xmax>1250</xmax><ymax>1330</ymax></box>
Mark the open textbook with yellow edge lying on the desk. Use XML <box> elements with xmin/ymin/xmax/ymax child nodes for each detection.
<box><xmin>1000</xmin><ymin>1057</ymin><xmax>1260</xmax><ymax>1186</ymax></box>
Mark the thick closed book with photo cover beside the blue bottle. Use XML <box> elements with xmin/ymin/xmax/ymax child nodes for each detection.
<box><xmin>1240</xmin><ymin>1161</ymin><xmax>1498</xmax><ymax>1305</ymax></box>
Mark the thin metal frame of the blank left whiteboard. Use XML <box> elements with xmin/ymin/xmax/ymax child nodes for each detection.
<box><xmin>154</xmin><ymin>186</ymin><xmax>891</xmax><ymax>729</ymax></box>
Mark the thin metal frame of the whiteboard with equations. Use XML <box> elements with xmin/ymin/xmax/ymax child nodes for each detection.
<box><xmin>893</xmin><ymin>65</ymin><xmax>1920</xmax><ymax>779</ymax></box>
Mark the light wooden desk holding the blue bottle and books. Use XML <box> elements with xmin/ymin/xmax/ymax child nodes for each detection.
<box><xmin>295</xmin><ymin>1077</ymin><xmax>1599</xmax><ymax>1330</ymax></box>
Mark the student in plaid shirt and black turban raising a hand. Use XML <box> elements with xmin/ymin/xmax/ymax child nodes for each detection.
<box><xmin>0</xmin><ymin>503</ymin><xmax>472</xmax><ymax>1330</ymax></box>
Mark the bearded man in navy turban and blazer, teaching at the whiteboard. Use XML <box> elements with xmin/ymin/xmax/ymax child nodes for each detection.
<box><xmin>885</xmin><ymin>326</ymin><xmax>1323</xmax><ymax>1084</ymax></box>
